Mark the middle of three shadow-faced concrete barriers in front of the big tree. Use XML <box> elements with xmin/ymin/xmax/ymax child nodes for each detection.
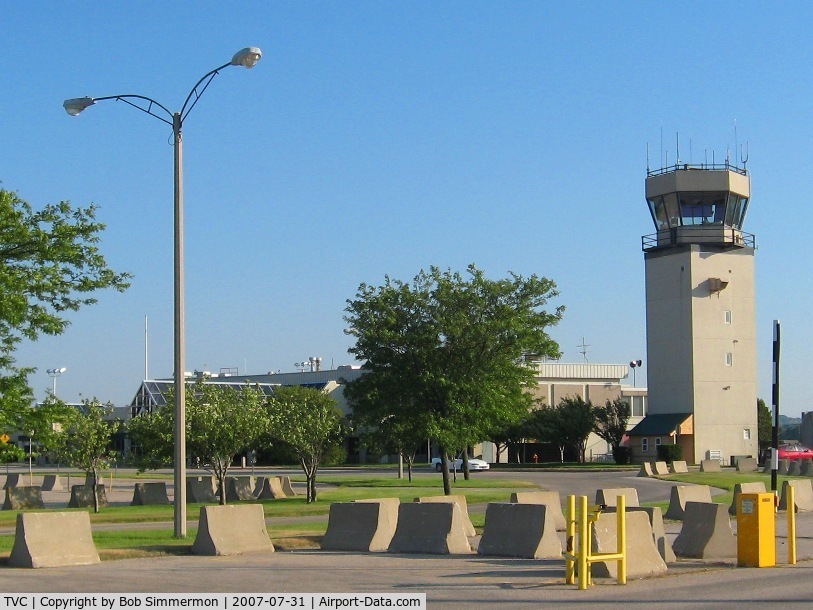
<box><xmin>389</xmin><ymin>502</ymin><xmax>471</xmax><ymax>555</ymax></box>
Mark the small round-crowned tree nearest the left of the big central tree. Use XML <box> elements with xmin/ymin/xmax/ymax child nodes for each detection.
<box><xmin>268</xmin><ymin>386</ymin><xmax>344</xmax><ymax>503</ymax></box>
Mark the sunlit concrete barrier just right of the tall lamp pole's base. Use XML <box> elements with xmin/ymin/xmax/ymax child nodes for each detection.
<box><xmin>192</xmin><ymin>504</ymin><xmax>274</xmax><ymax>555</ymax></box>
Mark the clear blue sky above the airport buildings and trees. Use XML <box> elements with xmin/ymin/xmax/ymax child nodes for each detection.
<box><xmin>0</xmin><ymin>0</ymin><xmax>813</xmax><ymax>414</ymax></box>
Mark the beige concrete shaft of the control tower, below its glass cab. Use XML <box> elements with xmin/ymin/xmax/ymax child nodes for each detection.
<box><xmin>645</xmin><ymin>245</ymin><xmax>758</xmax><ymax>462</ymax></box>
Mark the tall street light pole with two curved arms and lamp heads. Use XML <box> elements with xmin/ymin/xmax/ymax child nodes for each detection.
<box><xmin>67</xmin><ymin>47</ymin><xmax>262</xmax><ymax>538</ymax></box>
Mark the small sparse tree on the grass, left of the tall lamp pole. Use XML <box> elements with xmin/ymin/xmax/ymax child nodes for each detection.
<box><xmin>48</xmin><ymin>399</ymin><xmax>121</xmax><ymax>513</ymax></box>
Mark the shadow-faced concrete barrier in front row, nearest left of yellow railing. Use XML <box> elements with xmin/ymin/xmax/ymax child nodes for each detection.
<box><xmin>477</xmin><ymin>502</ymin><xmax>562</xmax><ymax>559</ymax></box>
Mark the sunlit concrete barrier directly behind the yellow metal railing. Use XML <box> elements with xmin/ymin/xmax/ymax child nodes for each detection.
<box><xmin>592</xmin><ymin>510</ymin><xmax>666</xmax><ymax>578</ymax></box>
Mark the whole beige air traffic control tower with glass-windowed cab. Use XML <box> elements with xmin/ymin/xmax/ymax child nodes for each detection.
<box><xmin>642</xmin><ymin>163</ymin><xmax>758</xmax><ymax>464</ymax></box>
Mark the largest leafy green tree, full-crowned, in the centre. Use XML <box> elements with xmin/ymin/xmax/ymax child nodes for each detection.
<box><xmin>345</xmin><ymin>265</ymin><xmax>564</xmax><ymax>494</ymax></box>
